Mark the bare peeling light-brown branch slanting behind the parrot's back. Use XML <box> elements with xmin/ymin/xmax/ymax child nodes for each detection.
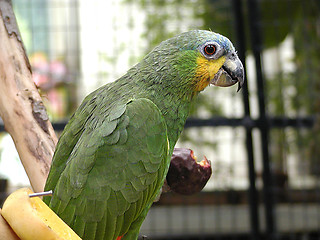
<box><xmin>0</xmin><ymin>0</ymin><xmax>57</xmax><ymax>192</ymax></box>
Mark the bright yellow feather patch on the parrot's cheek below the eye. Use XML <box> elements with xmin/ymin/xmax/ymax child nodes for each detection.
<box><xmin>194</xmin><ymin>55</ymin><xmax>226</xmax><ymax>92</ymax></box>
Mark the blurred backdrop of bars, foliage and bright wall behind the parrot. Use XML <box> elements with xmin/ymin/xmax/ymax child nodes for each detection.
<box><xmin>0</xmin><ymin>0</ymin><xmax>320</xmax><ymax>240</ymax></box>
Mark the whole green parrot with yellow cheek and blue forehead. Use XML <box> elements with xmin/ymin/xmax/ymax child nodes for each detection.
<box><xmin>44</xmin><ymin>30</ymin><xmax>244</xmax><ymax>240</ymax></box>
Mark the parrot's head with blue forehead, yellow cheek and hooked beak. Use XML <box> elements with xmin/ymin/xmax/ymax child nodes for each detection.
<box><xmin>139</xmin><ymin>30</ymin><xmax>244</xmax><ymax>95</ymax></box>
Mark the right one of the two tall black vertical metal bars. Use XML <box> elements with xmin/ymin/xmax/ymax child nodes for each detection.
<box><xmin>248</xmin><ymin>0</ymin><xmax>276</xmax><ymax>240</ymax></box>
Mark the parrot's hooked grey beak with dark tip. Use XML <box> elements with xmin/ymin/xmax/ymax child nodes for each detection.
<box><xmin>211</xmin><ymin>52</ymin><xmax>244</xmax><ymax>92</ymax></box>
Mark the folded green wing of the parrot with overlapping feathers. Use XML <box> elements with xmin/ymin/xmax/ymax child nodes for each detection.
<box><xmin>46</xmin><ymin>98</ymin><xmax>170</xmax><ymax>239</ymax></box>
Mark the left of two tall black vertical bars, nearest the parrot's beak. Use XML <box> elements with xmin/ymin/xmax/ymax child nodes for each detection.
<box><xmin>232</xmin><ymin>0</ymin><xmax>260</xmax><ymax>240</ymax></box>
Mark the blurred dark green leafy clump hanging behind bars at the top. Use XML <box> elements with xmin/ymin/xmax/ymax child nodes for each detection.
<box><xmin>201</xmin><ymin>0</ymin><xmax>301</xmax><ymax>50</ymax></box>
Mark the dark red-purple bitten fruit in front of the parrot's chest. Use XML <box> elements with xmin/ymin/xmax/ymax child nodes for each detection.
<box><xmin>167</xmin><ymin>148</ymin><xmax>212</xmax><ymax>195</ymax></box>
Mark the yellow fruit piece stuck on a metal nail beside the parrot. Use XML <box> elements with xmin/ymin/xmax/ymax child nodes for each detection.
<box><xmin>0</xmin><ymin>188</ymin><xmax>81</xmax><ymax>240</ymax></box>
